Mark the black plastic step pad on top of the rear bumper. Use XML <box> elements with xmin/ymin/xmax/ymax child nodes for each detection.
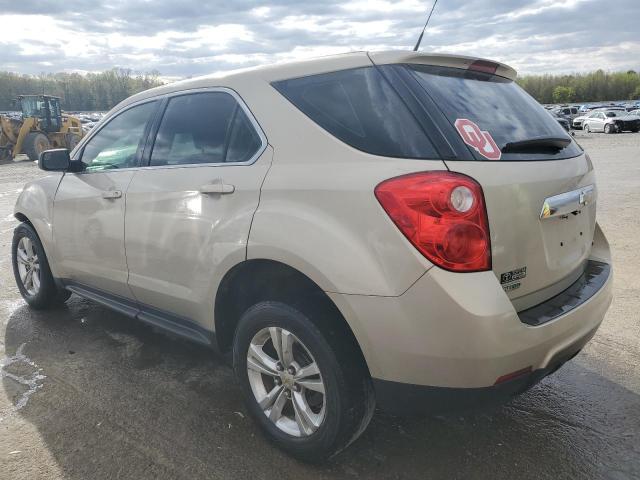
<box><xmin>518</xmin><ymin>260</ymin><xmax>611</xmax><ymax>327</ymax></box>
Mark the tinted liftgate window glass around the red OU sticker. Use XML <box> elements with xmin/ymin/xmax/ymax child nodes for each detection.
<box><xmin>408</xmin><ymin>65</ymin><xmax>582</xmax><ymax>160</ymax></box>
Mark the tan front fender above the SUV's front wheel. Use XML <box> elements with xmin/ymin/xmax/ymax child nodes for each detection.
<box><xmin>13</xmin><ymin>172</ymin><xmax>64</xmax><ymax>276</ymax></box>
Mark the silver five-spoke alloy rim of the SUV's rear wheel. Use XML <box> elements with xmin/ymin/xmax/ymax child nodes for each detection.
<box><xmin>247</xmin><ymin>327</ymin><xmax>326</xmax><ymax>437</ymax></box>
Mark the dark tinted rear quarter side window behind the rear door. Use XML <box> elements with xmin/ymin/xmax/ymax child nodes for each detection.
<box><xmin>273</xmin><ymin>67</ymin><xmax>437</xmax><ymax>158</ymax></box>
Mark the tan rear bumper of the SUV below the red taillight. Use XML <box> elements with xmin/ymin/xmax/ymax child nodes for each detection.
<box><xmin>330</xmin><ymin>227</ymin><xmax>613</xmax><ymax>408</ymax></box>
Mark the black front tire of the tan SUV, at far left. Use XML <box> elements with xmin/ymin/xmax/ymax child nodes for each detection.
<box><xmin>11</xmin><ymin>223</ymin><xmax>71</xmax><ymax>310</ymax></box>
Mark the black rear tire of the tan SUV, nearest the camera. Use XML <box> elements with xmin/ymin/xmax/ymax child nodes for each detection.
<box><xmin>233</xmin><ymin>301</ymin><xmax>375</xmax><ymax>462</ymax></box>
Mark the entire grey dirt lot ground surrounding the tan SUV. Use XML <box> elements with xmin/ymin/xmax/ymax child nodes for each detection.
<box><xmin>0</xmin><ymin>133</ymin><xmax>640</xmax><ymax>480</ymax></box>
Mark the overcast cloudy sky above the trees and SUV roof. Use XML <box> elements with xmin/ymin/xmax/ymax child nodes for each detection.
<box><xmin>0</xmin><ymin>0</ymin><xmax>640</xmax><ymax>78</ymax></box>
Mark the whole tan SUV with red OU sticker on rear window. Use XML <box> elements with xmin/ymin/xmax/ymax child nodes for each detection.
<box><xmin>13</xmin><ymin>52</ymin><xmax>612</xmax><ymax>459</ymax></box>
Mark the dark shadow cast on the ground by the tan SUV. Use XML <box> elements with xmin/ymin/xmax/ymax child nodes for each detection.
<box><xmin>2</xmin><ymin>296</ymin><xmax>640</xmax><ymax>480</ymax></box>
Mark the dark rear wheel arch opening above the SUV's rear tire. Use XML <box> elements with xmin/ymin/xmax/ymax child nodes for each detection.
<box><xmin>214</xmin><ymin>259</ymin><xmax>369</xmax><ymax>373</ymax></box>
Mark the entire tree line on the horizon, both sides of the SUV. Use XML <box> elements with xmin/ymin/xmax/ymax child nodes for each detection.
<box><xmin>0</xmin><ymin>68</ymin><xmax>640</xmax><ymax>111</ymax></box>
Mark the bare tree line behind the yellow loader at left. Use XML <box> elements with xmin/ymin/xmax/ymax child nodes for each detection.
<box><xmin>0</xmin><ymin>68</ymin><xmax>163</xmax><ymax>111</ymax></box>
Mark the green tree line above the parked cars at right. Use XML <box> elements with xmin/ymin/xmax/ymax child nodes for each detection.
<box><xmin>518</xmin><ymin>70</ymin><xmax>640</xmax><ymax>103</ymax></box>
